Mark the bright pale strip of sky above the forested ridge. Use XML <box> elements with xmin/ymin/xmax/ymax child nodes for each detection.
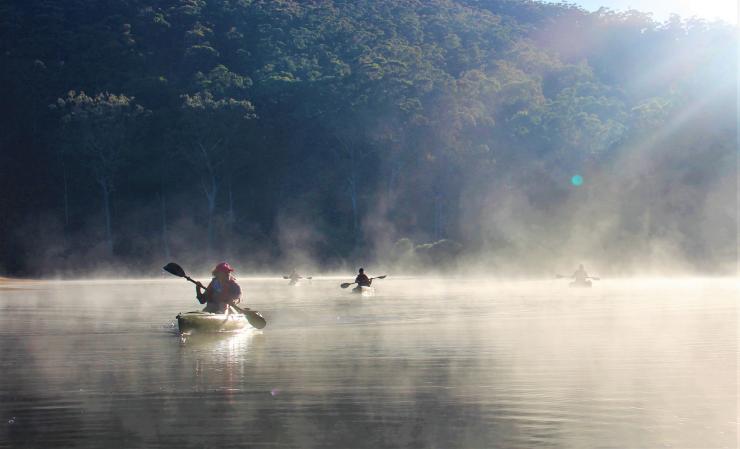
<box><xmin>556</xmin><ymin>0</ymin><xmax>738</xmax><ymax>24</ymax></box>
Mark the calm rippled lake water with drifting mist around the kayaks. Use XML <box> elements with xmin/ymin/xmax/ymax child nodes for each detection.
<box><xmin>0</xmin><ymin>278</ymin><xmax>740</xmax><ymax>449</ymax></box>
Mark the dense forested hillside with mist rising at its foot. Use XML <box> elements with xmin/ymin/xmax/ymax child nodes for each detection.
<box><xmin>0</xmin><ymin>0</ymin><xmax>737</xmax><ymax>275</ymax></box>
